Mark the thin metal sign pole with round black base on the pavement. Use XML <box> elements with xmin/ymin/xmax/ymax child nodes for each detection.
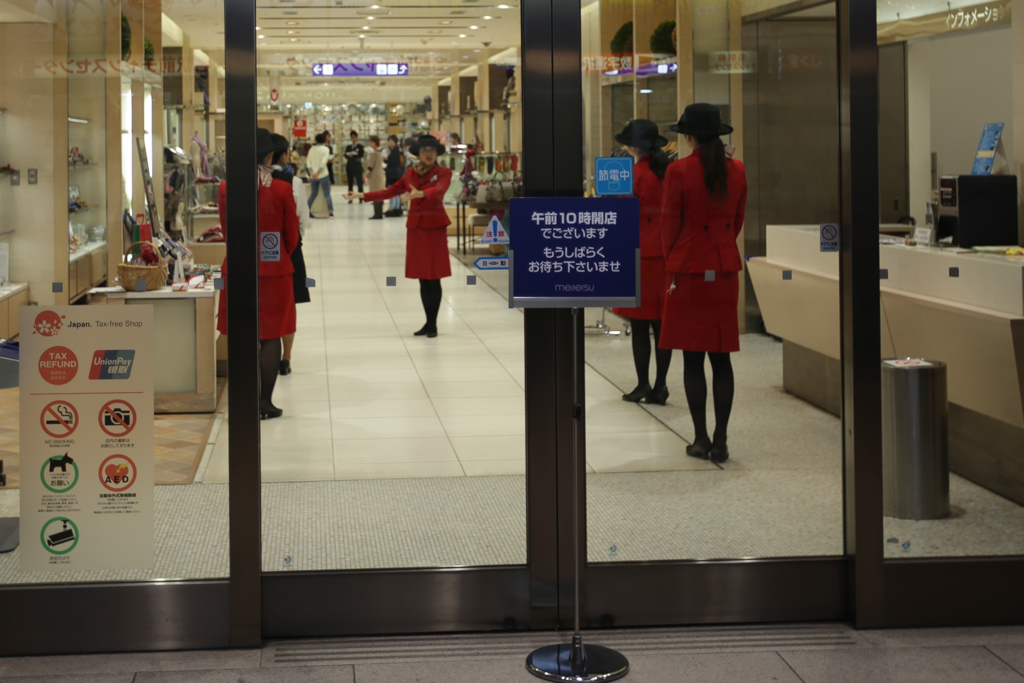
<box><xmin>526</xmin><ymin>306</ymin><xmax>630</xmax><ymax>683</ymax></box>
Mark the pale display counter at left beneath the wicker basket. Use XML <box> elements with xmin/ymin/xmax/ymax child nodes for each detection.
<box><xmin>90</xmin><ymin>283</ymin><xmax>220</xmax><ymax>413</ymax></box>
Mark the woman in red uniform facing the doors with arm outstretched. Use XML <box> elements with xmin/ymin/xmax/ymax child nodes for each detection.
<box><xmin>348</xmin><ymin>135</ymin><xmax>452</xmax><ymax>337</ymax></box>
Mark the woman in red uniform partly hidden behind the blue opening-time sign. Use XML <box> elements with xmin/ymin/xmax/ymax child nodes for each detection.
<box><xmin>612</xmin><ymin>119</ymin><xmax>672</xmax><ymax>405</ymax></box>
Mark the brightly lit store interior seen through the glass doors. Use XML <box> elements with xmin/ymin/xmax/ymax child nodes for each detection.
<box><xmin>0</xmin><ymin>0</ymin><xmax>1024</xmax><ymax>584</ymax></box>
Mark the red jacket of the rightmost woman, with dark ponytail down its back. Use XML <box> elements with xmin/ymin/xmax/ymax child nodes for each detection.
<box><xmin>662</xmin><ymin>150</ymin><xmax>746</xmax><ymax>272</ymax></box>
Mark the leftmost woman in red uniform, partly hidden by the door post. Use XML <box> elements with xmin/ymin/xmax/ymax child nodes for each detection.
<box><xmin>217</xmin><ymin>128</ymin><xmax>299</xmax><ymax>420</ymax></box>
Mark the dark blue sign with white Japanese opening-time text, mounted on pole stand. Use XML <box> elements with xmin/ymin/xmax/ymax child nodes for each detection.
<box><xmin>509</xmin><ymin>197</ymin><xmax>640</xmax><ymax>308</ymax></box>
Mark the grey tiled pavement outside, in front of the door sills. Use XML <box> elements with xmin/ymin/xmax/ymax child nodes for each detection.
<box><xmin>0</xmin><ymin>624</ymin><xmax>1024</xmax><ymax>683</ymax></box>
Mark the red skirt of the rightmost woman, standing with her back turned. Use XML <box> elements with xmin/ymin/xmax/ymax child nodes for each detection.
<box><xmin>658</xmin><ymin>272</ymin><xmax>739</xmax><ymax>353</ymax></box>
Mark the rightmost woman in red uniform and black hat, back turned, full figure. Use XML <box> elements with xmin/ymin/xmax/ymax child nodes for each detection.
<box><xmin>660</xmin><ymin>103</ymin><xmax>746</xmax><ymax>463</ymax></box>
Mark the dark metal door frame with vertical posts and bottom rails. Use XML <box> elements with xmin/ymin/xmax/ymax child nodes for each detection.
<box><xmin>0</xmin><ymin>0</ymin><xmax>1024</xmax><ymax>655</ymax></box>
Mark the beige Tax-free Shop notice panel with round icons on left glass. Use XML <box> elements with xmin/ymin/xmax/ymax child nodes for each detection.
<box><xmin>20</xmin><ymin>306</ymin><xmax>154</xmax><ymax>571</ymax></box>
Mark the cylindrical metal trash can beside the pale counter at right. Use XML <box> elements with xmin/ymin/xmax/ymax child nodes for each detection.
<box><xmin>882</xmin><ymin>358</ymin><xmax>949</xmax><ymax>519</ymax></box>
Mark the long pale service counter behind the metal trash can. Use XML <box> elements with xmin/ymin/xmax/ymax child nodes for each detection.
<box><xmin>748</xmin><ymin>225</ymin><xmax>1024</xmax><ymax>504</ymax></box>
